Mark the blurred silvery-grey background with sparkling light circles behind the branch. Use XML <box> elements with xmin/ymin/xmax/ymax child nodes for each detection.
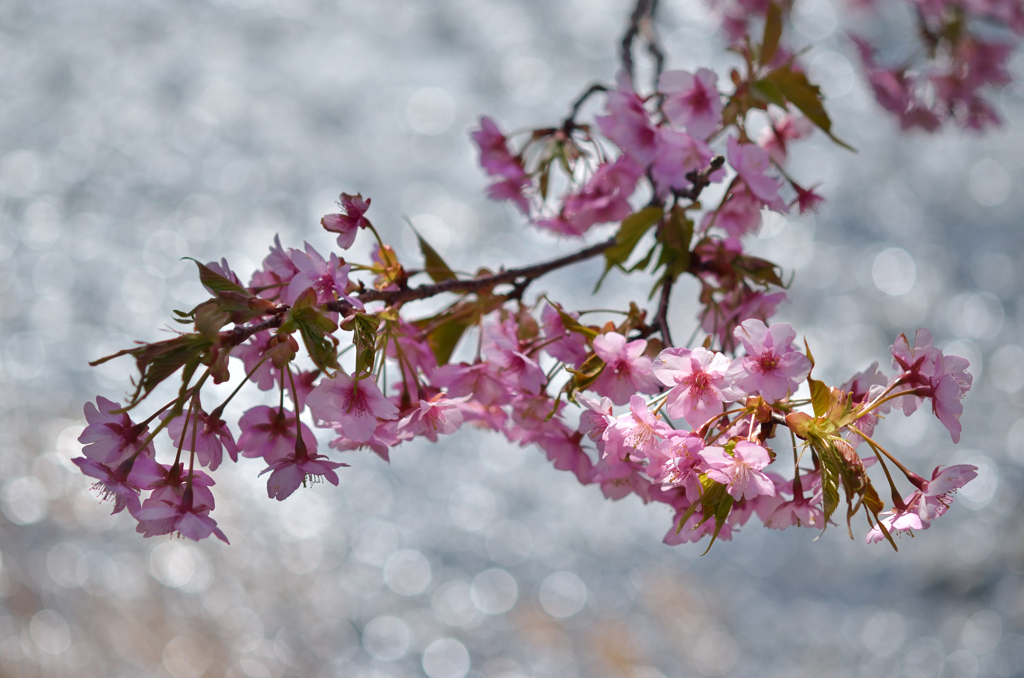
<box><xmin>0</xmin><ymin>0</ymin><xmax>1024</xmax><ymax>678</ymax></box>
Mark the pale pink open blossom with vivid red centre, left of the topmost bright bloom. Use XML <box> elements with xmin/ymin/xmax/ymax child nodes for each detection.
<box><xmin>651</xmin><ymin>346</ymin><xmax>732</xmax><ymax>429</ymax></box>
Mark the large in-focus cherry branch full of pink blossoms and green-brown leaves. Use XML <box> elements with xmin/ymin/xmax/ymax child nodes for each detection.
<box><xmin>75</xmin><ymin>0</ymin><xmax>991</xmax><ymax>547</ymax></box>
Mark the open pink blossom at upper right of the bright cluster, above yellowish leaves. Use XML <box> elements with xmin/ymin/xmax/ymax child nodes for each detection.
<box><xmin>725</xmin><ymin>320</ymin><xmax>811</xmax><ymax>402</ymax></box>
